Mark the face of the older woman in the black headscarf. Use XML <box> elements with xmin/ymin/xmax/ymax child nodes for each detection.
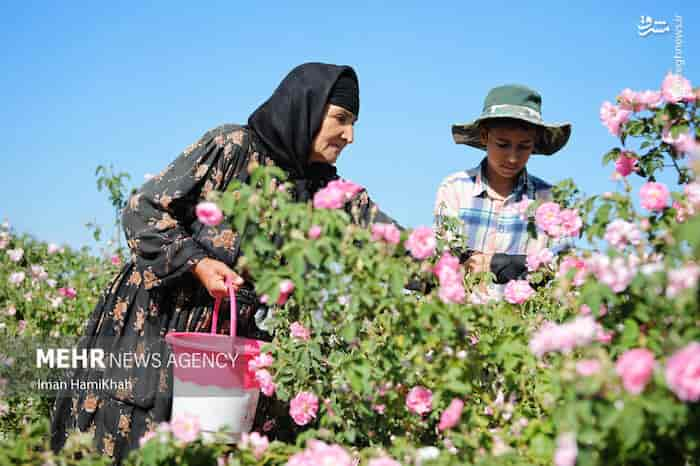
<box><xmin>309</xmin><ymin>104</ymin><xmax>357</xmax><ymax>164</ymax></box>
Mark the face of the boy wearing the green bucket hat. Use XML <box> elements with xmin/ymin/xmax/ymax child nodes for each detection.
<box><xmin>482</xmin><ymin>128</ymin><xmax>537</xmax><ymax>180</ymax></box>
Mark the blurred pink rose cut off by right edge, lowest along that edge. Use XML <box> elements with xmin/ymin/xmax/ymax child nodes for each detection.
<box><xmin>665</xmin><ymin>341</ymin><xmax>700</xmax><ymax>403</ymax></box>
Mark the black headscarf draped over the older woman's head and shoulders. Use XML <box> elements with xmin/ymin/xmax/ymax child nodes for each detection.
<box><xmin>248</xmin><ymin>63</ymin><xmax>357</xmax><ymax>200</ymax></box>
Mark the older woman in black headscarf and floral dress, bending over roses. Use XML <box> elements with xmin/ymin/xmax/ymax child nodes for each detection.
<box><xmin>52</xmin><ymin>63</ymin><xmax>391</xmax><ymax>463</ymax></box>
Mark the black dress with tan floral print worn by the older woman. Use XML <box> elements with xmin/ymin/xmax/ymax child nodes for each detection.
<box><xmin>51</xmin><ymin>125</ymin><xmax>391</xmax><ymax>463</ymax></box>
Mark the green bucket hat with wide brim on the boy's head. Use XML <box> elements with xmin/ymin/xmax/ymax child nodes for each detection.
<box><xmin>452</xmin><ymin>84</ymin><xmax>571</xmax><ymax>155</ymax></box>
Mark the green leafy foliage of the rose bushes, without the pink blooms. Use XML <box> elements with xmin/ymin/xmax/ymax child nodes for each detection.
<box><xmin>0</xmin><ymin>83</ymin><xmax>700</xmax><ymax>466</ymax></box>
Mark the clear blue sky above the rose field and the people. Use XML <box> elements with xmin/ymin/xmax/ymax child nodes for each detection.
<box><xmin>0</xmin><ymin>0</ymin><xmax>700</xmax><ymax>251</ymax></box>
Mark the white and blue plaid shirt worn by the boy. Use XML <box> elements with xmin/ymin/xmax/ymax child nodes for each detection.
<box><xmin>434</xmin><ymin>159</ymin><xmax>552</xmax><ymax>254</ymax></box>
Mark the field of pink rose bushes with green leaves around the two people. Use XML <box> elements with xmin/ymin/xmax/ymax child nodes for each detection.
<box><xmin>0</xmin><ymin>74</ymin><xmax>700</xmax><ymax>466</ymax></box>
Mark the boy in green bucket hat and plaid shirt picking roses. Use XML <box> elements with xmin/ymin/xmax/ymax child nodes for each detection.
<box><xmin>434</xmin><ymin>85</ymin><xmax>571</xmax><ymax>284</ymax></box>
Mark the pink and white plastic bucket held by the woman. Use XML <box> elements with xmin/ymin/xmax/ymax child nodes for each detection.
<box><xmin>165</xmin><ymin>280</ymin><xmax>265</xmax><ymax>441</ymax></box>
